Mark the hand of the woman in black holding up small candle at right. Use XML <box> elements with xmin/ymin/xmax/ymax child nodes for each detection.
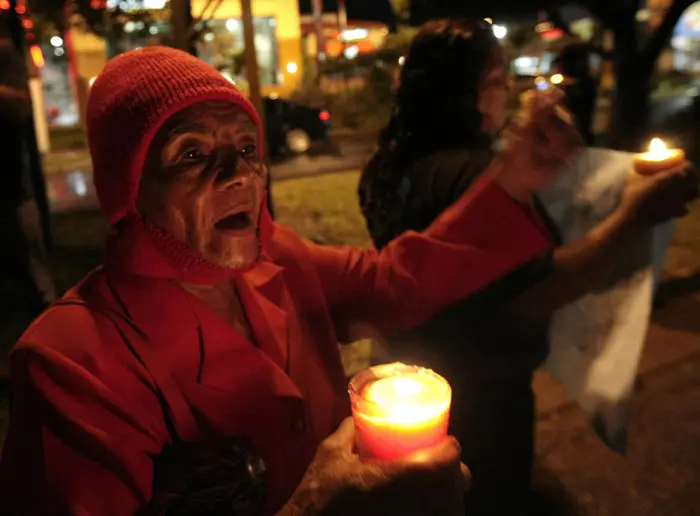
<box><xmin>620</xmin><ymin>163</ymin><xmax>698</xmax><ymax>227</ymax></box>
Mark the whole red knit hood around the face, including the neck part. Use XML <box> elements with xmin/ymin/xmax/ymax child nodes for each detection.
<box><xmin>87</xmin><ymin>47</ymin><xmax>274</xmax><ymax>283</ymax></box>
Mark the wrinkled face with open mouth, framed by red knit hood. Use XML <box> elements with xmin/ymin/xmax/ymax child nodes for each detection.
<box><xmin>138</xmin><ymin>101</ymin><xmax>267</xmax><ymax>269</ymax></box>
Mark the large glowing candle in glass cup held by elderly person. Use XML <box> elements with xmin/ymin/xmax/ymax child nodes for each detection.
<box><xmin>349</xmin><ymin>363</ymin><xmax>452</xmax><ymax>460</ymax></box>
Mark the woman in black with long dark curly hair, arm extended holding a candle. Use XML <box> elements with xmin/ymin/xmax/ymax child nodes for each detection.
<box><xmin>359</xmin><ymin>20</ymin><xmax>696</xmax><ymax>516</ymax></box>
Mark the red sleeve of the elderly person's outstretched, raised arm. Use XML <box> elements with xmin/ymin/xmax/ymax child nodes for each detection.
<box><xmin>307</xmin><ymin>176</ymin><xmax>552</xmax><ymax>341</ymax></box>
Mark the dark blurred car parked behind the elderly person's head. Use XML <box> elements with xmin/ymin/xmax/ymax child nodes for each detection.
<box><xmin>263</xmin><ymin>97</ymin><xmax>331</xmax><ymax>156</ymax></box>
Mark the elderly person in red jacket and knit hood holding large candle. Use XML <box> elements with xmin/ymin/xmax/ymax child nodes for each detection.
<box><xmin>1</xmin><ymin>47</ymin><xmax>575</xmax><ymax>516</ymax></box>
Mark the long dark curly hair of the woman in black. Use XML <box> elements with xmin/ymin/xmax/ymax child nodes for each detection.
<box><xmin>359</xmin><ymin>19</ymin><xmax>503</xmax><ymax>248</ymax></box>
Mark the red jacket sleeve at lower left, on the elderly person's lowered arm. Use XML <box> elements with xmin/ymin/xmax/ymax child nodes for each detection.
<box><xmin>0</xmin><ymin>307</ymin><xmax>164</xmax><ymax>516</ymax></box>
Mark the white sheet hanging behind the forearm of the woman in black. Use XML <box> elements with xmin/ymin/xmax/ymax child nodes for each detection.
<box><xmin>542</xmin><ymin>148</ymin><xmax>673</xmax><ymax>452</ymax></box>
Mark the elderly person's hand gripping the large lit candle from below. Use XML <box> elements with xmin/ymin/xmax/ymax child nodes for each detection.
<box><xmin>280</xmin><ymin>418</ymin><xmax>469</xmax><ymax>516</ymax></box>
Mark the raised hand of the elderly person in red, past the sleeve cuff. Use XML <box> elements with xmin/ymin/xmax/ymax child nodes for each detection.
<box><xmin>496</xmin><ymin>88</ymin><xmax>583</xmax><ymax>202</ymax></box>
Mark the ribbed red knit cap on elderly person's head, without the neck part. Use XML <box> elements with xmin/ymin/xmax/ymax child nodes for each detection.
<box><xmin>87</xmin><ymin>47</ymin><xmax>263</xmax><ymax>224</ymax></box>
